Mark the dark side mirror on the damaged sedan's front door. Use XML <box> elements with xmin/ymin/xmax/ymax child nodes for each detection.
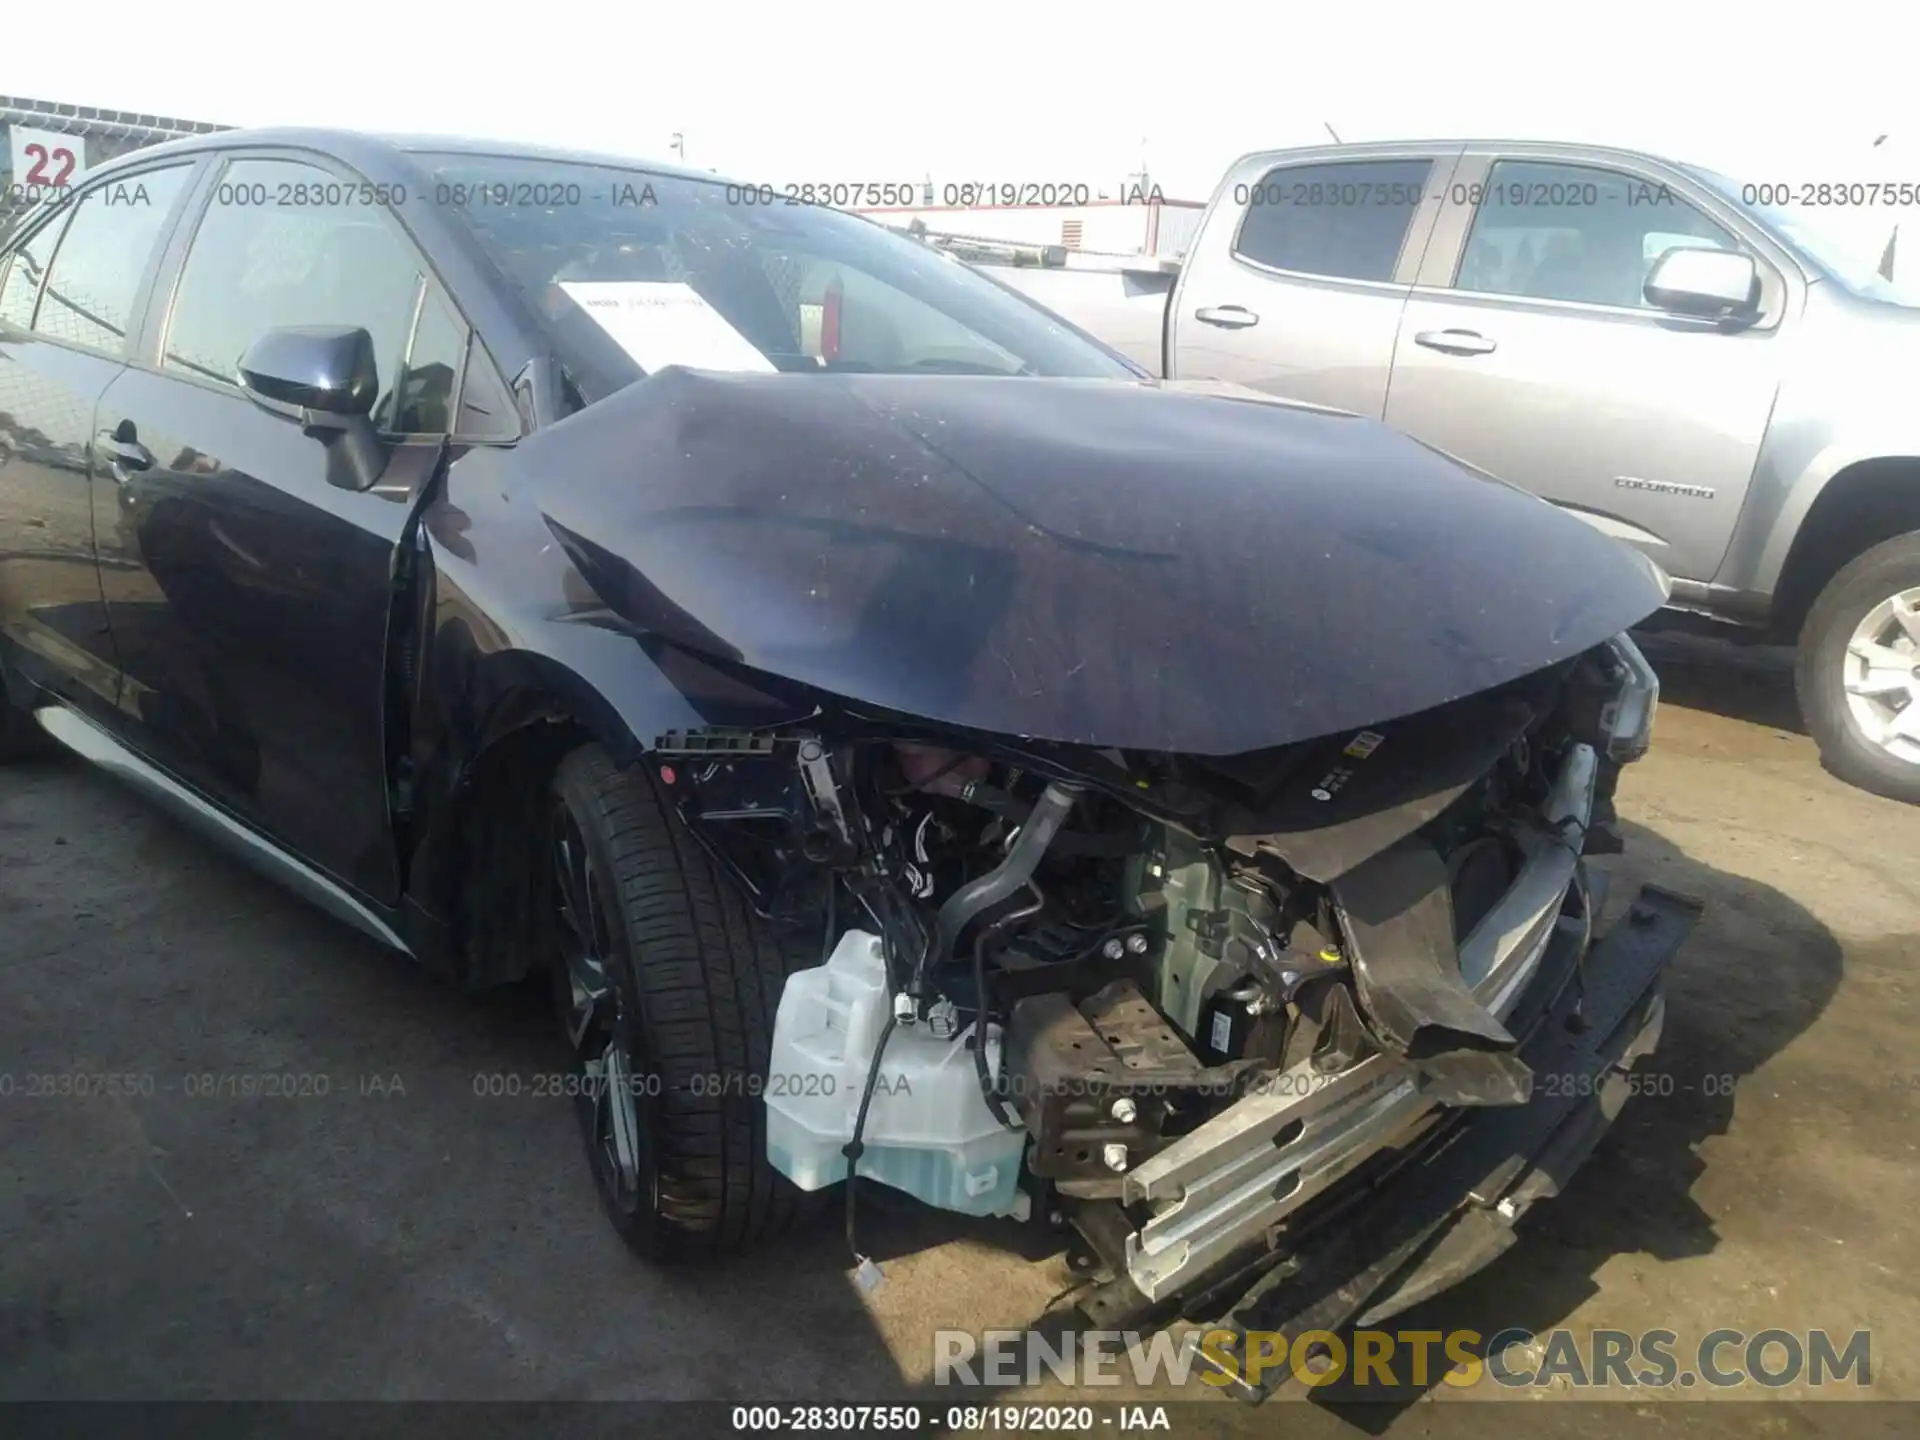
<box><xmin>240</xmin><ymin>324</ymin><xmax>388</xmax><ymax>490</ymax></box>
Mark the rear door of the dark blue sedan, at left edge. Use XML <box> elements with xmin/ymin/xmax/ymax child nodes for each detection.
<box><xmin>0</xmin><ymin>161</ymin><xmax>194</xmax><ymax>720</ymax></box>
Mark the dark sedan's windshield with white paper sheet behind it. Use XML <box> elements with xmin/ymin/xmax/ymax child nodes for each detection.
<box><xmin>415</xmin><ymin>152</ymin><xmax>1137</xmax><ymax>399</ymax></box>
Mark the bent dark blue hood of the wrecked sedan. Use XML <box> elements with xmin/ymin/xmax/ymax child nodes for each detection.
<box><xmin>499</xmin><ymin>369</ymin><xmax>1667</xmax><ymax>755</ymax></box>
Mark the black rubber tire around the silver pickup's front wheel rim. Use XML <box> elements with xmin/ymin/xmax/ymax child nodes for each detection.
<box><xmin>1793</xmin><ymin>532</ymin><xmax>1920</xmax><ymax>804</ymax></box>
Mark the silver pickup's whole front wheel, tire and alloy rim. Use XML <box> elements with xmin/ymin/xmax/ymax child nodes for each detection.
<box><xmin>1793</xmin><ymin>532</ymin><xmax>1920</xmax><ymax>804</ymax></box>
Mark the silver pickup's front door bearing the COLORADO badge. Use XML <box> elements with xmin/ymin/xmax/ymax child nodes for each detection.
<box><xmin>1386</xmin><ymin>152</ymin><xmax>1799</xmax><ymax>580</ymax></box>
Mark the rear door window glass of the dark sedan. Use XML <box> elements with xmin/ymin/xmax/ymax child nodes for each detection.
<box><xmin>33</xmin><ymin>165</ymin><xmax>192</xmax><ymax>353</ymax></box>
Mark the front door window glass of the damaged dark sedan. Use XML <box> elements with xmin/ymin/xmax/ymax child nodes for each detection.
<box><xmin>161</xmin><ymin>159</ymin><xmax>424</xmax><ymax>430</ymax></box>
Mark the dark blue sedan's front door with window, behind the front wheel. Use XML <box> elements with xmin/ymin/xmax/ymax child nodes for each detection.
<box><xmin>94</xmin><ymin>154</ymin><xmax>510</xmax><ymax>902</ymax></box>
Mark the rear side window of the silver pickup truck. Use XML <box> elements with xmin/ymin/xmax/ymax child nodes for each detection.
<box><xmin>1233</xmin><ymin>159</ymin><xmax>1432</xmax><ymax>280</ymax></box>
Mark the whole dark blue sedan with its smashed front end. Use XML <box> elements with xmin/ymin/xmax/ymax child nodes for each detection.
<box><xmin>0</xmin><ymin>131</ymin><xmax>1693</xmax><ymax>1397</ymax></box>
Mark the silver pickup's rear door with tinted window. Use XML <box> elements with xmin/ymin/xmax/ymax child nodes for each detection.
<box><xmin>1169</xmin><ymin>146</ymin><xmax>1459</xmax><ymax>419</ymax></box>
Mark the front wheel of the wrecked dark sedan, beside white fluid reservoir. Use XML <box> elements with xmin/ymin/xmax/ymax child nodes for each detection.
<box><xmin>547</xmin><ymin>745</ymin><xmax>810</xmax><ymax>1261</ymax></box>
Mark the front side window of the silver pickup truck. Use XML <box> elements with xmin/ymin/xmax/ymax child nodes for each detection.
<box><xmin>1453</xmin><ymin>159</ymin><xmax>1740</xmax><ymax>309</ymax></box>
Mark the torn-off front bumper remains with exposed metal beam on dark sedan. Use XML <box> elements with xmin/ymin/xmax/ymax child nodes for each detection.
<box><xmin>1075</xmin><ymin>636</ymin><xmax>1695</xmax><ymax>1367</ymax></box>
